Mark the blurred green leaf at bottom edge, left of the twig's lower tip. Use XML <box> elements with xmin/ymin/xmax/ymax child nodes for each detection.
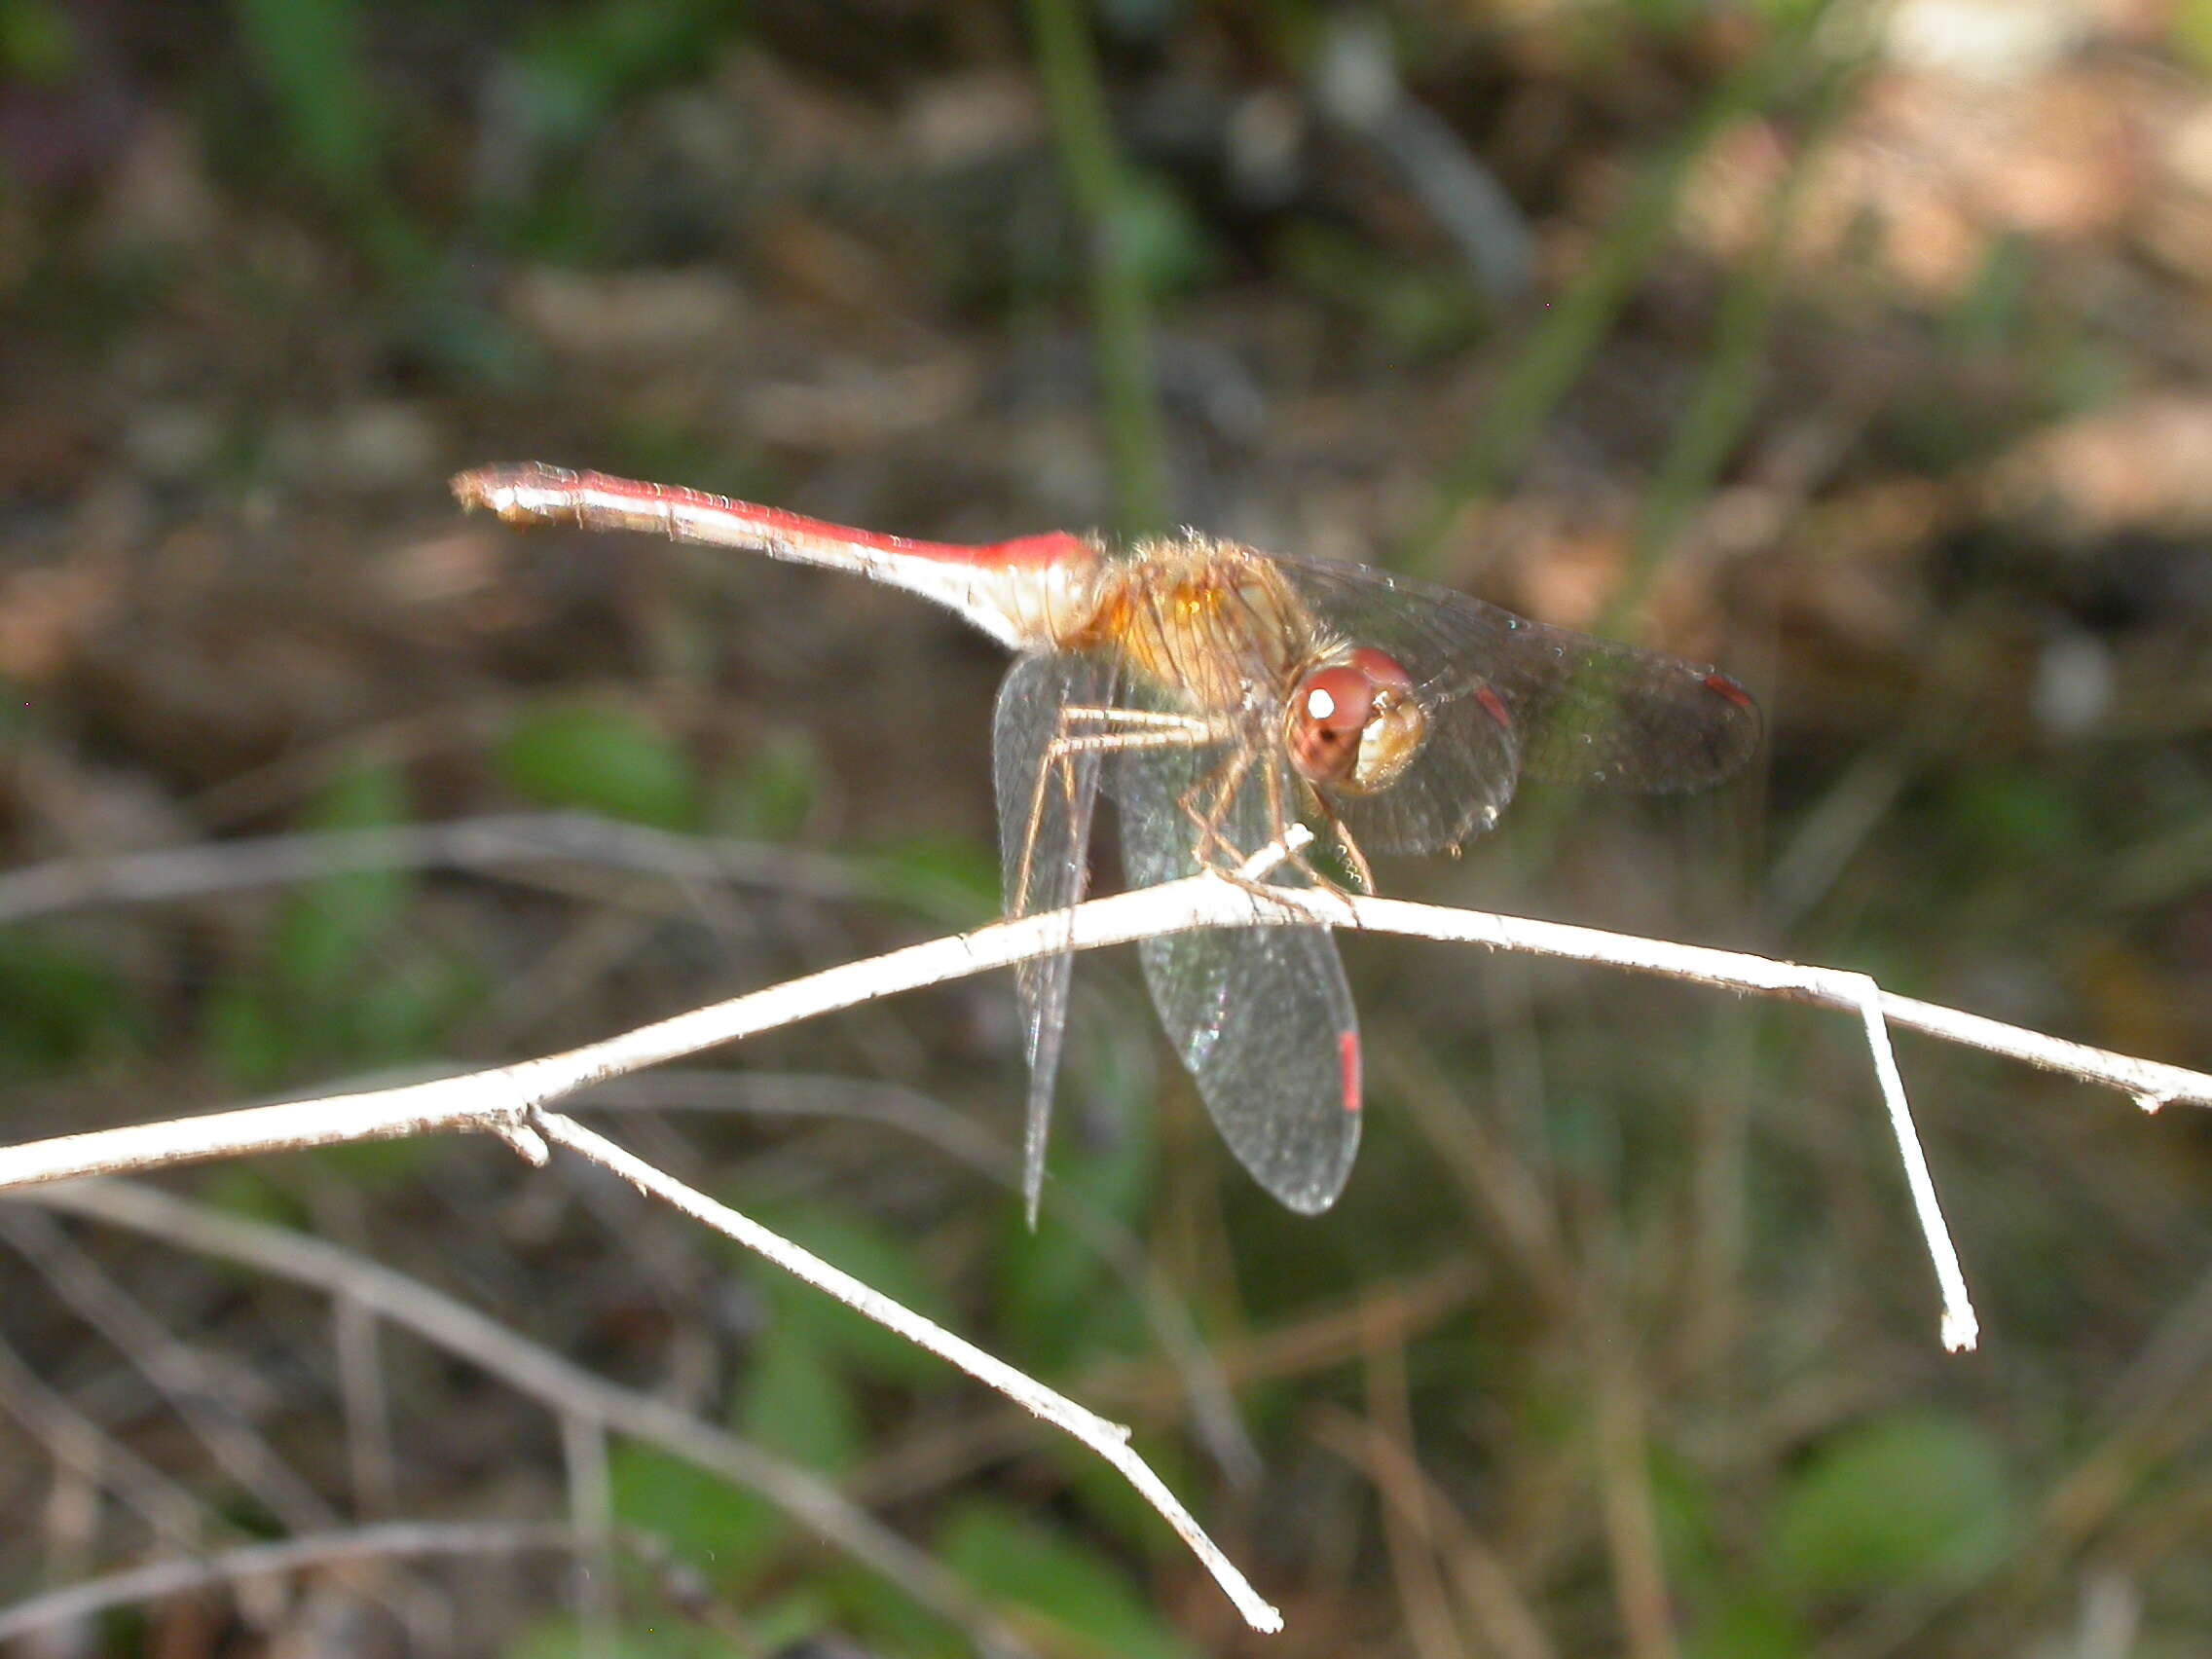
<box><xmin>938</xmin><ymin>1502</ymin><xmax>1190</xmax><ymax>1659</ymax></box>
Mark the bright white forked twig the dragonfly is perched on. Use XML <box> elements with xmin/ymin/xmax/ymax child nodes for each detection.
<box><xmin>0</xmin><ymin>873</ymin><xmax>2212</xmax><ymax>1630</ymax></box>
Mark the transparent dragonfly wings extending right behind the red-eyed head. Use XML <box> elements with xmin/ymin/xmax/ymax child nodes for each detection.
<box><xmin>1276</xmin><ymin>555</ymin><xmax>1761</xmax><ymax>852</ymax></box>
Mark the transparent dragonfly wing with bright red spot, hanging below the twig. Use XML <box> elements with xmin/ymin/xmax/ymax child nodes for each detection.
<box><xmin>1111</xmin><ymin>717</ymin><xmax>1360</xmax><ymax>1214</ymax></box>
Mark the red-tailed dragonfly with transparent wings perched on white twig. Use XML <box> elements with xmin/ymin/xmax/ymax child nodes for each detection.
<box><xmin>451</xmin><ymin>462</ymin><xmax>1761</xmax><ymax>1223</ymax></box>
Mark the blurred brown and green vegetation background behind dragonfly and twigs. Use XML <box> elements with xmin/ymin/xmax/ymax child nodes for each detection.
<box><xmin>0</xmin><ymin>0</ymin><xmax>2212</xmax><ymax>1659</ymax></box>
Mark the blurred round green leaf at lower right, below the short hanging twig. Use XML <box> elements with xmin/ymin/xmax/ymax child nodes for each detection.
<box><xmin>1774</xmin><ymin>1412</ymin><xmax>2019</xmax><ymax>1595</ymax></box>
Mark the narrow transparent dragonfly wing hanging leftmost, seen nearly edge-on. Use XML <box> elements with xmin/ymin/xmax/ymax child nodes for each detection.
<box><xmin>991</xmin><ymin>652</ymin><xmax>1115</xmax><ymax>1226</ymax></box>
